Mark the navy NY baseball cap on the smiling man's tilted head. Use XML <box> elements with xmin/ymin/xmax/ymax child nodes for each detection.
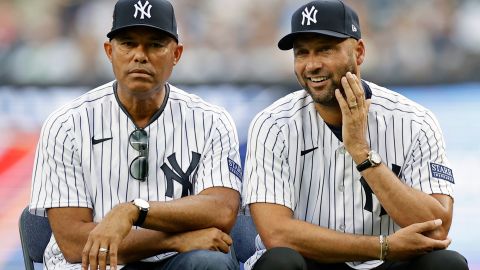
<box><xmin>278</xmin><ymin>0</ymin><xmax>362</xmax><ymax>50</ymax></box>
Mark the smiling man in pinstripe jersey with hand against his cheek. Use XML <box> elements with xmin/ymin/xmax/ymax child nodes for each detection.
<box><xmin>242</xmin><ymin>0</ymin><xmax>468</xmax><ymax>270</ymax></box>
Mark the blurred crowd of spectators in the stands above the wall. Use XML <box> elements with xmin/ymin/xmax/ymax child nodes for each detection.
<box><xmin>0</xmin><ymin>0</ymin><xmax>480</xmax><ymax>86</ymax></box>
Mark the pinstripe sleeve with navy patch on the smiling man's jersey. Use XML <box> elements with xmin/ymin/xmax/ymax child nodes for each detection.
<box><xmin>403</xmin><ymin>112</ymin><xmax>455</xmax><ymax>197</ymax></box>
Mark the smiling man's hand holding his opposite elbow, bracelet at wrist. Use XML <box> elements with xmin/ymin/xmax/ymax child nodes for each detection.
<box><xmin>387</xmin><ymin>219</ymin><xmax>452</xmax><ymax>261</ymax></box>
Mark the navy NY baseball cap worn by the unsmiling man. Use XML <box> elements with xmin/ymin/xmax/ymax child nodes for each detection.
<box><xmin>107</xmin><ymin>0</ymin><xmax>178</xmax><ymax>42</ymax></box>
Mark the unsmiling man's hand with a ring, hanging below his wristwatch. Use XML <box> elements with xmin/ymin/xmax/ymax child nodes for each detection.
<box><xmin>82</xmin><ymin>203</ymin><xmax>138</xmax><ymax>270</ymax></box>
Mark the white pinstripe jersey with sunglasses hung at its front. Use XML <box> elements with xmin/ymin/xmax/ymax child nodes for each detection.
<box><xmin>30</xmin><ymin>82</ymin><xmax>241</xmax><ymax>269</ymax></box>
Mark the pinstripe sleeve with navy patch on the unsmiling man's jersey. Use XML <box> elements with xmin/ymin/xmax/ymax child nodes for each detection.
<box><xmin>194</xmin><ymin>111</ymin><xmax>242</xmax><ymax>194</ymax></box>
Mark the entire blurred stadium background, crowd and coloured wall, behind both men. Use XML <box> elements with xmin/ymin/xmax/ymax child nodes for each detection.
<box><xmin>0</xmin><ymin>0</ymin><xmax>480</xmax><ymax>270</ymax></box>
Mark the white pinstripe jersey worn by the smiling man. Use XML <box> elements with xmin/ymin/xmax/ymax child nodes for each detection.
<box><xmin>243</xmin><ymin>82</ymin><xmax>453</xmax><ymax>269</ymax></box>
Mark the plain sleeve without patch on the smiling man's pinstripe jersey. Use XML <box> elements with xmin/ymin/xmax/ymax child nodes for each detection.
<box><xmin>243</xmin><ymin>114</ymin><xmax>295</xmax><ymax>210</ymax></box>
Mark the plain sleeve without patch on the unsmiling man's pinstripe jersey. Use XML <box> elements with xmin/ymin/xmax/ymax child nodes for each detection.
<box><xmin>30</xmin><ymin>112</ymin><xmax>92</xmax><ymax>216</ymax></box>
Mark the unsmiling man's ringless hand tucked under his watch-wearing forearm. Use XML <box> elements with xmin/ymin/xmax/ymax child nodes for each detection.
<box><xmin>172</xmin><ymin>228</ymin><xmax>233</xmax><ymax>253</ymax></box>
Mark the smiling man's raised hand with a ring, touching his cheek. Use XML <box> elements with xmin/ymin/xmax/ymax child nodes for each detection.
<box><xmin>335</xmin><ymin>72</ymin><xmax>371</xmax><ymax>158</ymax></box>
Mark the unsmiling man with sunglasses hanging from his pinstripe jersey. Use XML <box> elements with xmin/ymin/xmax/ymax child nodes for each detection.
<box><xmin>30</xmin><ymin>0</ymin><xmax>242</xmax><ymax>270</ymax></box>
